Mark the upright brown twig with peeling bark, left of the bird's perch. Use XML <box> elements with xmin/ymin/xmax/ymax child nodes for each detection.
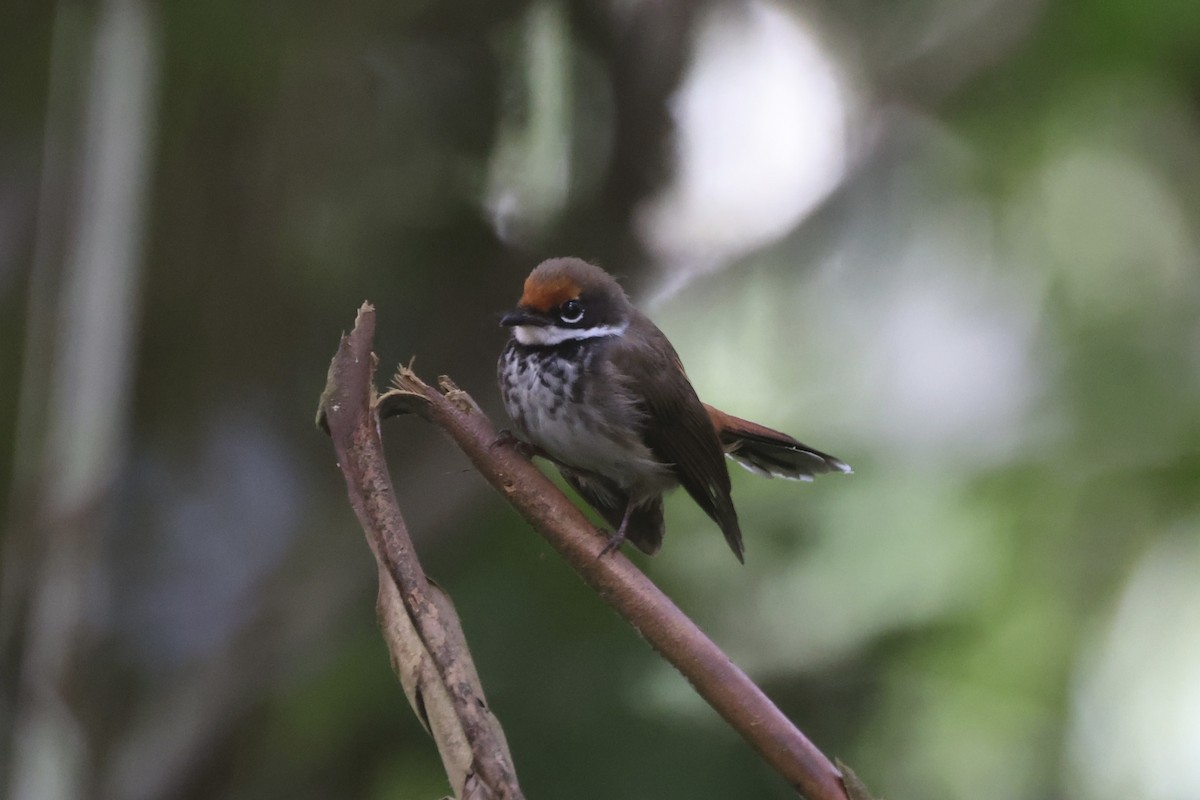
<box><xmin>317</xmin><ymin>303</ymin><xmax>522</xmax><ymax>800</ymax></box>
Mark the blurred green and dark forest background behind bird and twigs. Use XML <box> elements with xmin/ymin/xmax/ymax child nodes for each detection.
<box><xmin>0</xmin><ymin>0</ymin><xmax>1200</xmax><ymax>800</ymax></box>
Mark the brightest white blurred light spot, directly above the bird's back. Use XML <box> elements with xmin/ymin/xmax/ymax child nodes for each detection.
<box><xmin>637</xmin><ymin>1</ymin><xmax>850</xmax><ymax>267</ymax></box>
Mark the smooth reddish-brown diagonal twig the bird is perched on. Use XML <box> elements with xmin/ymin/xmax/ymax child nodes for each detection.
<box><xmin>379</xmin><ymin>368</ymin><xmax>863</xmax><ymax>800</ymax></box>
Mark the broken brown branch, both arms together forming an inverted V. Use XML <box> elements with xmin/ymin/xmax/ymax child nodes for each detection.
<box><xmin>318</xmin><ymin>305</ymin><xmax>870</xmax><ymax>800</ymax></box>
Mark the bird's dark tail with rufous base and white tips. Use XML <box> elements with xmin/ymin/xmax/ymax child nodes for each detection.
<box><xmin>704</xmin><ymin>403</ymin><xmax>853</xmax><ymax>481</ymax></box>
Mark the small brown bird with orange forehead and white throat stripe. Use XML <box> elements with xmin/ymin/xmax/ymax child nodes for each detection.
<box><xmin>498</xmin><ymin>258</ymin><xmax>851</xmax><ymax>561</ymax></box>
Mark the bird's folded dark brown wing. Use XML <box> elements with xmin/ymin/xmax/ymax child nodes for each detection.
<box><xmin>612</xmin><ymin>312</ymin><xmax>745</xmax><ymax>561</ymax></box>
